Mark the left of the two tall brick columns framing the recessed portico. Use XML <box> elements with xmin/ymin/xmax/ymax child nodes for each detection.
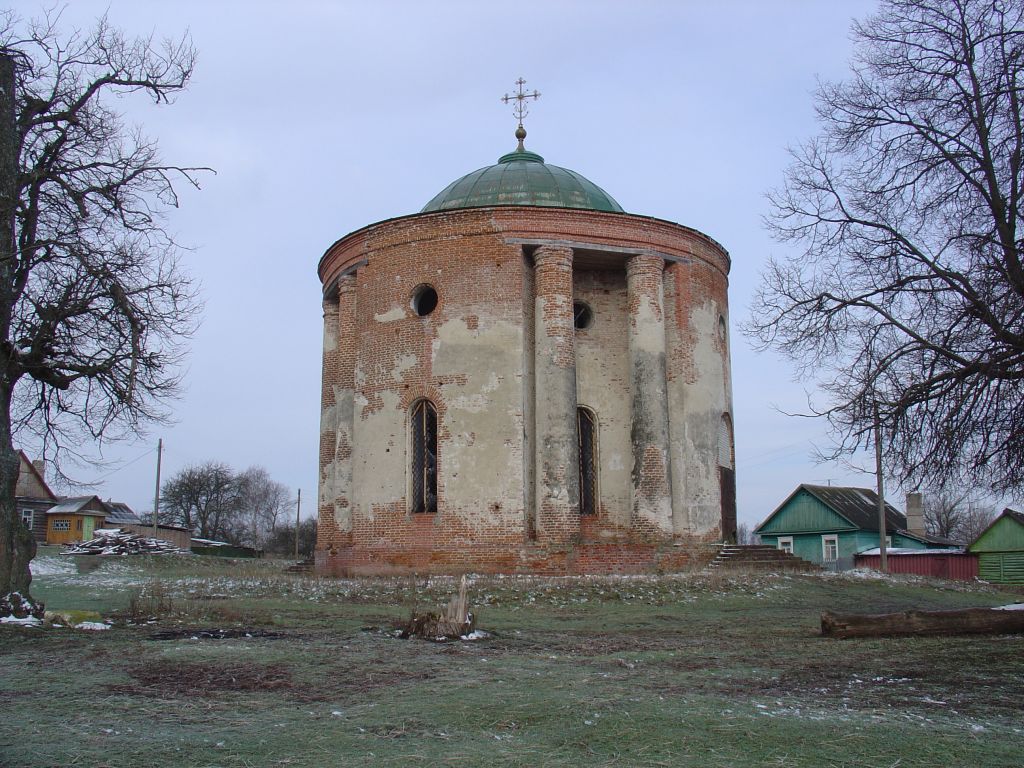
<box><xmin>534</xmin><ymin>246</ymin><xmax>580</xmax><ymax>544</ymax></box>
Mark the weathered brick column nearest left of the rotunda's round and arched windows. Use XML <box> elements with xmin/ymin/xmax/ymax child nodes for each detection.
<box><xmin>334</xmin><ymin>274</ymin><xmax>356</xmax><ymax>543</ymax></box>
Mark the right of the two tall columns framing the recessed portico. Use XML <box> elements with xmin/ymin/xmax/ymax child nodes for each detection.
<box><xmin>626</xmin><ymin>255</ymin><xmax>673</xmax><ymax>536</ymax></box>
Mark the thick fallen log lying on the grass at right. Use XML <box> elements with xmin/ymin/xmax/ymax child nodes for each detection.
<box><xmin>821</xmin><ymin>608</ymin><xmax>1024</xmax><ymax>638</ymax></box>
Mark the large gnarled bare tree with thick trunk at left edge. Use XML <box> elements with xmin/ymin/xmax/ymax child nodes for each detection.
<box><xmin>0</xmin><ymin>11</ymin><xmax>200</xmax><ymax>606</ymax></box>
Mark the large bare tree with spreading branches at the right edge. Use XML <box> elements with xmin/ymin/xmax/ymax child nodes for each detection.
<box><xmin>746</xmin><ymin>0</ymin><xmax>1024</xmax><ymax>494</ymax></box>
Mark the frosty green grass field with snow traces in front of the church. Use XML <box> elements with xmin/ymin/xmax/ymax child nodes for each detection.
<box><xmin>0</xmin><ymin>548</ymin><xmax>1024</xmax><ymax>768</ymax></box>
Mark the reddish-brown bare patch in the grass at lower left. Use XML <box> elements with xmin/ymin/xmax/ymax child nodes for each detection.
<box><xmin>108</xmin><ymin>662</ymin><xmax>294</xmax><ymax>697</ymax></box>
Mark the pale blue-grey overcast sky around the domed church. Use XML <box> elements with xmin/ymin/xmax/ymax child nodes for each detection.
<box><xmin>13</xmin><ymin>0</ymin><xmax>888</xmax><ymax>524</ymax></box>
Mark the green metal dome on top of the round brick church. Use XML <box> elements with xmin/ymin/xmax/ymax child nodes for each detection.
<box><xmin>421</xmin><ymin>145</ymin><xmax>624</xmax><ymax>213</ymax></box>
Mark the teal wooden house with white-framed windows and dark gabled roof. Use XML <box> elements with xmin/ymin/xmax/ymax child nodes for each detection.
<box><xmin>754</xmin><ymin>484</ymin><xmax>952</xmax><ymax>570</ymax></box>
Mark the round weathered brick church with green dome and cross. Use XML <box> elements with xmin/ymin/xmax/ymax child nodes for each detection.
<box><xmin>315</xmin><ymin>88</ymin><xmax>736</xmax><ymax>575</ymax></box>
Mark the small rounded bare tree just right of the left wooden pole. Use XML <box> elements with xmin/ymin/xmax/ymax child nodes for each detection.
<box><xmin>160</xmin><ymin>462</ymin><xmax>239</xmax><ymax>539</ymax></box>
